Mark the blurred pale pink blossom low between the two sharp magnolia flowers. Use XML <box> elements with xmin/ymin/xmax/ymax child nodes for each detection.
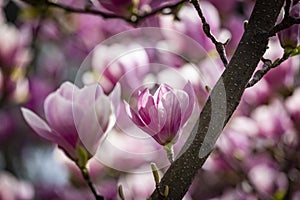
<box><xmin>95</xmin><ymin>126</ymin><xmax>157</xmax><ymax>172</ymax></box>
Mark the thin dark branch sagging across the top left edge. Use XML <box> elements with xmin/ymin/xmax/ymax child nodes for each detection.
<box><xmin>22</xmin><ymin>0</ymin><xmax>188</xmax><ymax>24</ymax></box>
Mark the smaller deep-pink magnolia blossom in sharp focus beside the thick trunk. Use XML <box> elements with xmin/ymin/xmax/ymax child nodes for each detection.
<box><xmin>127</xmin><ymin>82</ymin><xmax>195</xmax><ymax>146</ymax></box>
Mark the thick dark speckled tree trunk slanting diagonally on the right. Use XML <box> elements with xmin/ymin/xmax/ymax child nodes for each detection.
<box><xmin>151</xmin><ymin>0</ymin><xmax>284</xmax><ymax>200</ymax></box>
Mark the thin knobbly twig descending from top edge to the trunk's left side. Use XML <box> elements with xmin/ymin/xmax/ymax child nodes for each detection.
<box><xmin>191</xmin><ymin>0</ymin><xmax>229</xmax><ymax>67</ymax></box>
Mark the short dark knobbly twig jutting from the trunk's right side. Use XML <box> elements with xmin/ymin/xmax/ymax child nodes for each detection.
<box><xmin>246</xmin><ymin>53</ymin><xmax>289</xmax><ymax>88</ymax></box>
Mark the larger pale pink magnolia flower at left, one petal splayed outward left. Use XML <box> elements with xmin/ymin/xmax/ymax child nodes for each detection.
<box><xmin>21</xmin><ymin>82</ymin><xmax>120</xmax><ymax>159</ymax></box>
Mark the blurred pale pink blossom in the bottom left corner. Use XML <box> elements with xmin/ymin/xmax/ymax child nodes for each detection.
<box><xmin>0</xmin><ymin>172</ymin><xmax>34</xmax><ymax>200</ymax></box>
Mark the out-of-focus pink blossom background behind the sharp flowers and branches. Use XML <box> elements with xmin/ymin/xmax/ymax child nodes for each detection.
<box><xmin>0</xmin><ymin>0</ymin><xmax>300</xmax><ymax>200</ymax></box>
